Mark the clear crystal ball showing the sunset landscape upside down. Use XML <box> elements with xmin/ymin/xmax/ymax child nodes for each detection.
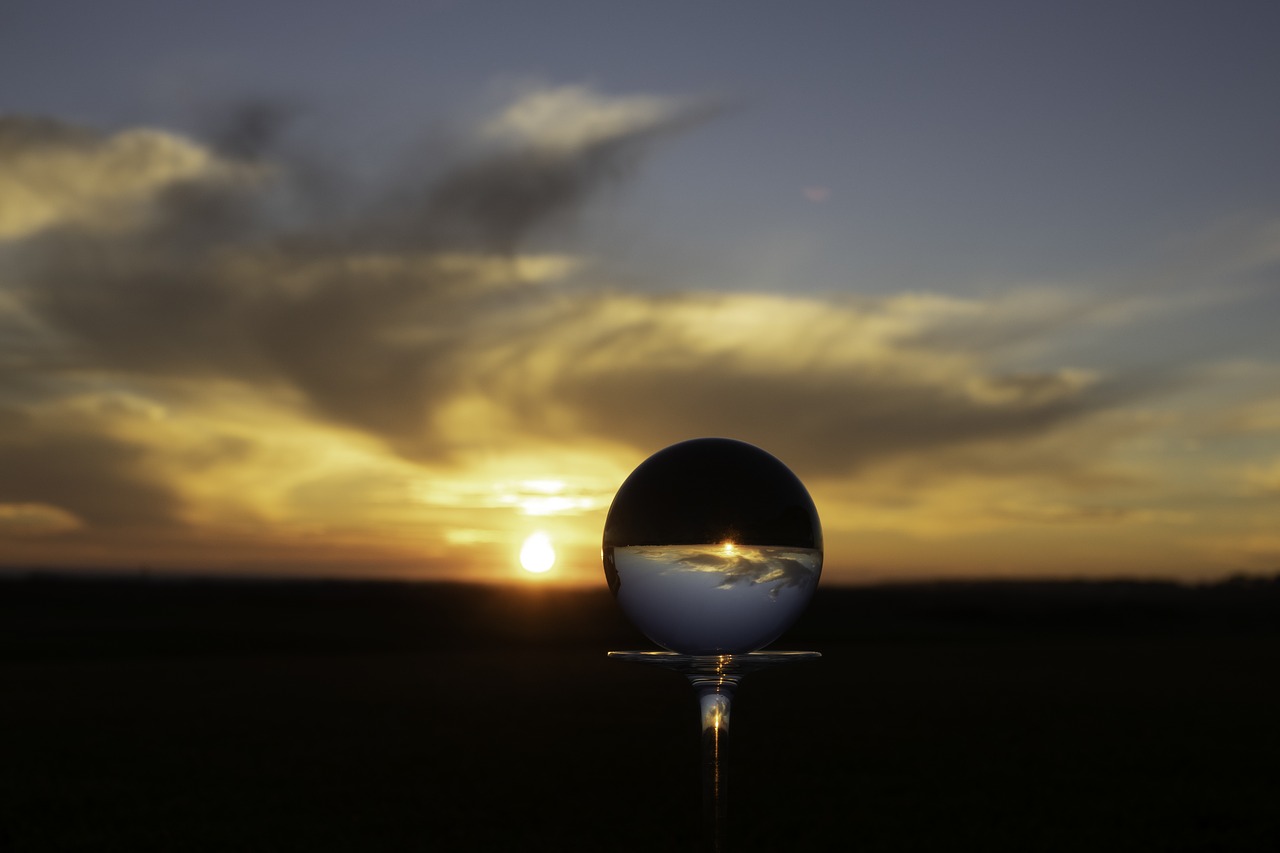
<box><xmin>603</xmin><ymin>438</ymin><xmax>822</xmax><ymax>654</ymax></box>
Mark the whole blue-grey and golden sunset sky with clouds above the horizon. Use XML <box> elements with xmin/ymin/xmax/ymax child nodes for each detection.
<box><xmin>0</xmin><ymin>0</ymin><xmax>1280</xmax><ymax>584</ymax></box>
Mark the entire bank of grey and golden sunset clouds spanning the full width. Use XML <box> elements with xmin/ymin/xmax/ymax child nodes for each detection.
<box><xmin>0</xmin><ymin>87</ymin><xmax>1276</xmax><ymax>578</ymax></box>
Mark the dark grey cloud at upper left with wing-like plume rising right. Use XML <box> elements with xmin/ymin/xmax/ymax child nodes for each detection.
<box><xmin>0</xmin><ymin>90</ymin><xmax>711</xmax><ymax>453</ymax></box>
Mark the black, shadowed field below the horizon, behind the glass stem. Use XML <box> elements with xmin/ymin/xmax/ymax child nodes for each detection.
<box><xmin>0</xmin><ymin>579</ymin><xmax>1280</xmax><ymax>853</ymax></box>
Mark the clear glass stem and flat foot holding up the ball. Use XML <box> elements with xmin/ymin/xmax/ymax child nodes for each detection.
<box><xmin>609</xmin><ymin>652</ymin><xmax>822</xmax><ymax>853</ymax></box>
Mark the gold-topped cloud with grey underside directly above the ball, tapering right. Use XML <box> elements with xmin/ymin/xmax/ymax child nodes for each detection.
<box><xmin>455</xmin><ymin>293</ymin><xmax>1136</xmax><ymax>476</ymax></box>
